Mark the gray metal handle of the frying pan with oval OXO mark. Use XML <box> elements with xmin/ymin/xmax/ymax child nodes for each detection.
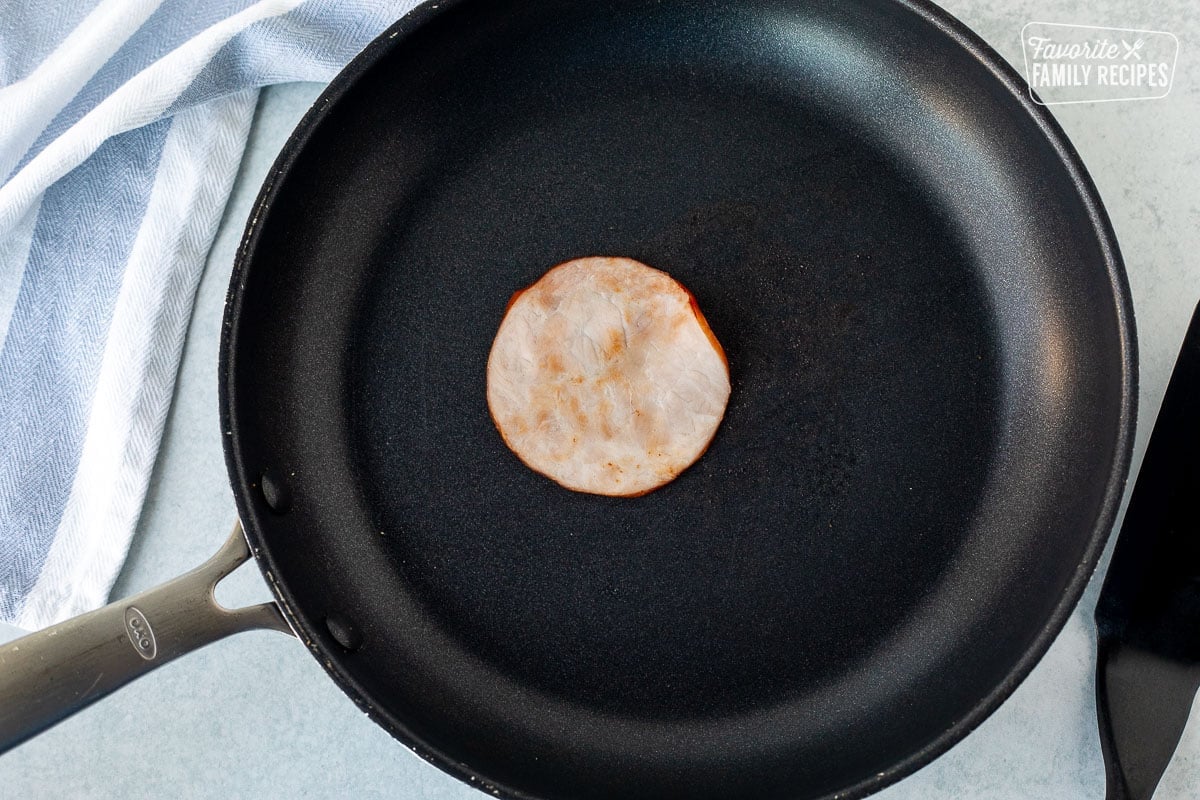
<box><xmin>0</xmin><ymin>522</ymin><xmax>292</xmax><ymax>753</ymax></box>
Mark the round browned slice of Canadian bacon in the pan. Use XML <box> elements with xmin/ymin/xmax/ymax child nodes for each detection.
<box><xmin>487</xmin><ymin>257</ymin><xmax>730</xmax><ymax>497</ymax></box>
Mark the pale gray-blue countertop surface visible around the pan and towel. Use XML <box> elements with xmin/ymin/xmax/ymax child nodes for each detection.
<box><xmin>0</xmin><ymin>0</ymin><xmax>1200</xmax><ymax>800</ymax></box>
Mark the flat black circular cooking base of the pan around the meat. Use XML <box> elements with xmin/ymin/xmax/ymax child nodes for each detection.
<box><xmin>348</xmin><ymin>87</ymin><xmax>998</xmax><ymax>718</ymax></box>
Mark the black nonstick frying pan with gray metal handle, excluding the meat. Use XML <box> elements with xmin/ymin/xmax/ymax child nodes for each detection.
<box><xmin>0</xmin><ymin>0</ymin><xmax>1136</xmax><ymax>800</ymax></box>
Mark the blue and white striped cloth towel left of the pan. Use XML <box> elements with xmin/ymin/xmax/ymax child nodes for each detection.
<box><xmin>0</xmin><ymin>0</ymin><xmax>415</xmax><ymax>628</ymax></box>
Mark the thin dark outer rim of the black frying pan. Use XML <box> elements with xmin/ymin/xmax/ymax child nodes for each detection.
<box><xmin>218</xmin><ymin>0</ymin><xmax>1138</xmax><ymax>800</ymax></box>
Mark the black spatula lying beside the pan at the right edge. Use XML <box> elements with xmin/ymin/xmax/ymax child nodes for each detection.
<box><xmin>1096</xmin><ymin>302</ymin><xmax>1200</xmax><ymax>800</ymax></box>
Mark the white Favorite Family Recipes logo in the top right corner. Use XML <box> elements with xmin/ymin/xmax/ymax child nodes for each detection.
<box><xmin>1021</xmin><ymin>23</ymin><xmax>1180</xmax><ymax>106</ymax></box>
